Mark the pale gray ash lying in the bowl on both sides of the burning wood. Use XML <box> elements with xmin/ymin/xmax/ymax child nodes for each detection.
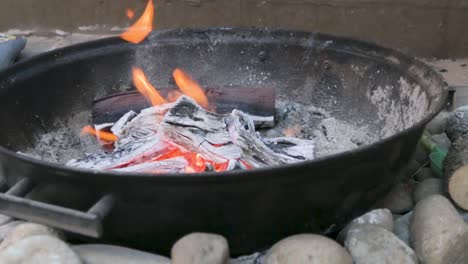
<box><xmin>21</xmin><ymin>99</ymin><xmax>378</xmax><ymax>164</ymax></box>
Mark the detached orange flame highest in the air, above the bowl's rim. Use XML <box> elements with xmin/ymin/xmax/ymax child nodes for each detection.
<box><xmin>120</xmin><ymin>0</ymin><xmax>154</xmax><ymax>44</ymax></box>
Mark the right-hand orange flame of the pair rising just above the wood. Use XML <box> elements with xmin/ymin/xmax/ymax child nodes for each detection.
<box><xmin>173</xmin><ymin>68</ymin><xmax>209</xmax><ymax>108</ymax></box>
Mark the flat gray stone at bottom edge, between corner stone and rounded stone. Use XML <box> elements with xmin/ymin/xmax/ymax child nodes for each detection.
<box><xmin>72</xmin><ymin>244</ymin><xmax>171</xmax><ymax>264</ymax></box>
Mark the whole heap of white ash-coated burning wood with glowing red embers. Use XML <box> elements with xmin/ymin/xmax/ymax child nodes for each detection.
<box><xmin>67</xmin><ymin>96</ymin><xmax>313</xmax><ymax>172</ymax></box>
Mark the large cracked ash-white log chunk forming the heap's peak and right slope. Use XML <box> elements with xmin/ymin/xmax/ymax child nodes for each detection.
<box><xmin>159</xmin><ymin>97</ymin><xmax>297</xmax><ymax>168</ymax></box>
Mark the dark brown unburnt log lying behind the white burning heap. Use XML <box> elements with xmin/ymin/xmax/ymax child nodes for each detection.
<box><xmin>92</xmin><ymin>88</ymin><xmax>275</xmax><ymax>127</ymax></box>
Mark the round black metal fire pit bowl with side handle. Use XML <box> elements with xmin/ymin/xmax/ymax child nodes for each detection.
<box><xmin>0</xmin><ymin>28</ymin><xmax>446</xmax><ymax>254</ymax></box>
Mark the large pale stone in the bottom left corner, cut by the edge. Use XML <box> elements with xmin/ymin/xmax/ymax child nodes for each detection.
<box><xmin>0</xmin><ymin>235</ymin><xmax>82</xmax><ymax>264</ymax></box>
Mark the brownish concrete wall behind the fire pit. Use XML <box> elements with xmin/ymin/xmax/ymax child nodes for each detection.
<box><xmin>0</xmin><ymin>0</ymin><xmax>468</xmax><ymax>57</ymax></box>
